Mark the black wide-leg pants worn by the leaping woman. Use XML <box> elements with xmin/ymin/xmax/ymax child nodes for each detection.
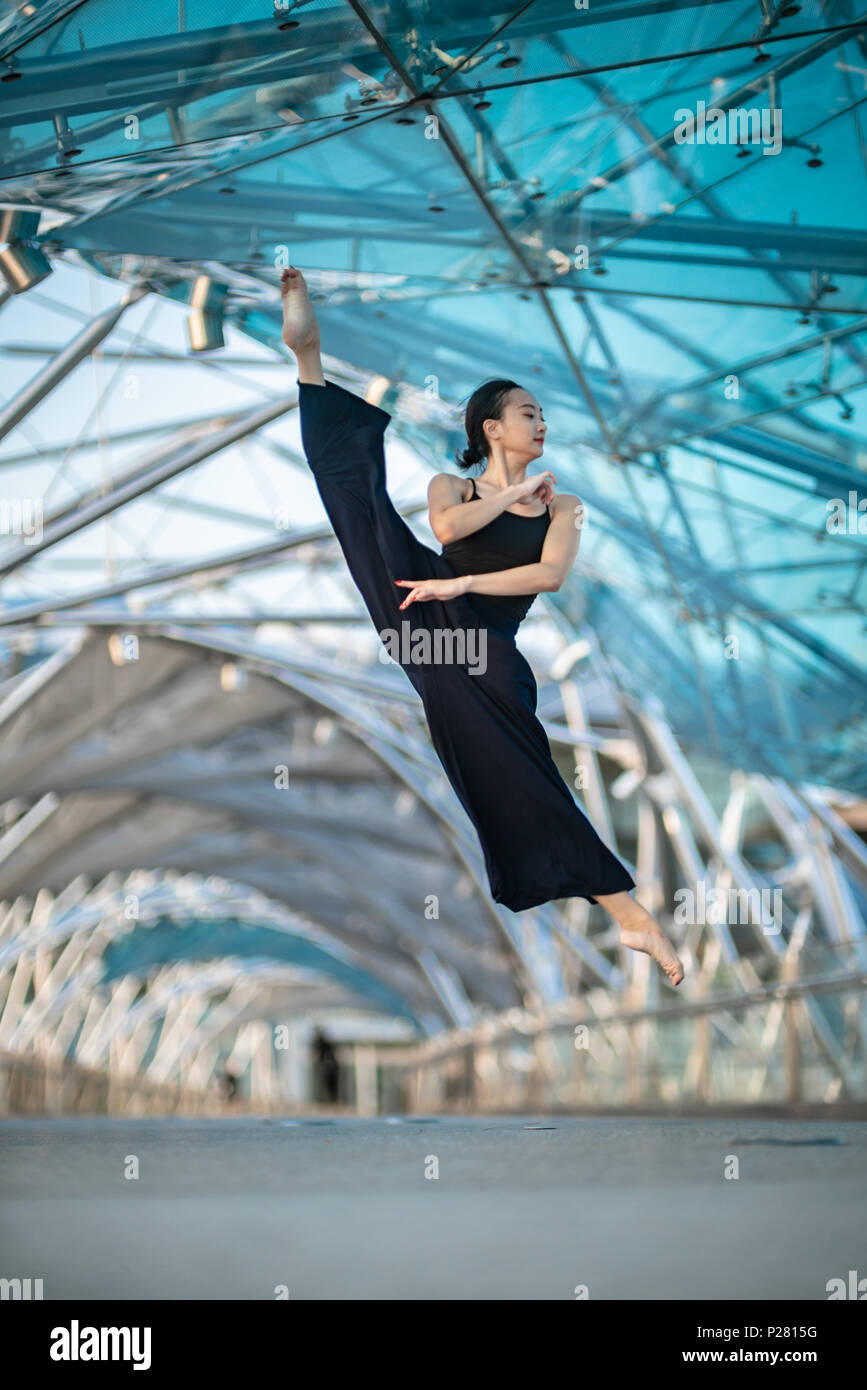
<box><xmin>299</xmin><ymin>381</ymin><xmax>635</xmax><ymax>912</ymax></box>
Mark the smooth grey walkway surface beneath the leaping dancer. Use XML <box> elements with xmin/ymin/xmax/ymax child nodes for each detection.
<box><xmin>0</xmin><ymin>1116</ymin><xmax>867</xmax><ymax>1301</ymax></box>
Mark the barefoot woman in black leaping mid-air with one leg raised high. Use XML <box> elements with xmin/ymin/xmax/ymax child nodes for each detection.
<box><xmin>281</xmin><ymin>267</ymin><xmax>684</xmax><ymax>984</ymax></box>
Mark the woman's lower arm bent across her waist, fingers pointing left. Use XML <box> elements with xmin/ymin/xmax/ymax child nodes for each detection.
<box><xmin>396</xmin><ymin>492</ymin><xmax>584</xmax><ymax>609</ymax></box>
